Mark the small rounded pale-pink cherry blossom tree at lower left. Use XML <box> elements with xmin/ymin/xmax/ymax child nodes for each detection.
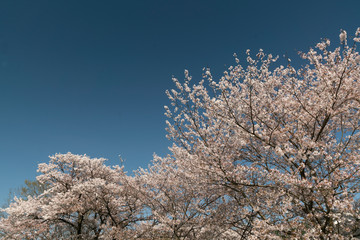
<box><xmin>0</xmin><ymin>153</ymin><xmax>141</xmax><ymax>239</ymax></box>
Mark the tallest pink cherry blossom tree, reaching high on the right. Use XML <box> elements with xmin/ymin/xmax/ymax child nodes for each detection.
<box><xmin>166</xmin><ymin>28</ymin><xmax>360</xmax><ymax>239</ymax></box>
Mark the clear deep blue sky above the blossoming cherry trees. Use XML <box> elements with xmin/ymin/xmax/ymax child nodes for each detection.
<box><xmin>0</xmin><ymin>0</ymin><xmax>360</xmax><ymax>202</ymax></box>
